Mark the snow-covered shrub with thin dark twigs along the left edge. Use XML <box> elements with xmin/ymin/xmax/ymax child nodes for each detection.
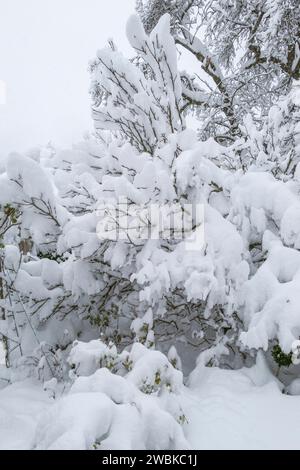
<box><xmin>0</xmin><ymin>152</ymin><xmax>95</xmax><ymax>379</ymax></box>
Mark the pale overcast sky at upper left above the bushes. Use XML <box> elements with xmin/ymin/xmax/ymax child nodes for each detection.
<box><xmin>0</xmin><ymin>0</ymin><xmax>135</xmax><ymax>155</ymax></box>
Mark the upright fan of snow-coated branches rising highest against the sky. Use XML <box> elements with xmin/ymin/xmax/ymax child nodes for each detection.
<box><xmin>91</xmin><ymin>16</ymin><xmax>183</xmax><ymax>153</ymax></box>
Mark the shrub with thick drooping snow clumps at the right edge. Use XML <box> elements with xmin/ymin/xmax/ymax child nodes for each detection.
<box><xmin>225</xmin><ymin>163</ymin><xmax>300</xmax><ymax>353</ymax></box>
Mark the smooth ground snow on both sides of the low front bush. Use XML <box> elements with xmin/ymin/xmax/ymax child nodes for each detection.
<box><xmin>0</xmin><ymin>360</ymin><xmax>300</xmax><ymax>449</ymax></box>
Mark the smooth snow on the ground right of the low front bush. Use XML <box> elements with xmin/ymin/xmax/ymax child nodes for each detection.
<box><xmin>185</xmin><ymin>368</ymin><xmax>300</xmax><ymax>449</ymax></box>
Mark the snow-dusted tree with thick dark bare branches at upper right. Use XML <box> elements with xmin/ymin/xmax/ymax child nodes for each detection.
<box><xmin>137</xmin><ymin>0</ymin><xmax>300</xmax><ymax>143</ymax></box>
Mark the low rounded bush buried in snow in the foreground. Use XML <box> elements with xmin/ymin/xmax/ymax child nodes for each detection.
<box><xmin>35</xmin><ymin>340</ymin><xmax>189</xmax><ymax>450</ymax></box>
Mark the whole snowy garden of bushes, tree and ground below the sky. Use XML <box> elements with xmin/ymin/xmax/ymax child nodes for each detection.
<box><xmin>0</xmin><ymin>0</ymin><xmax>300</xmax><ymax>450</ymax></box>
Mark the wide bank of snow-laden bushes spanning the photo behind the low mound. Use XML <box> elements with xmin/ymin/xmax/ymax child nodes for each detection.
<box><xmin>0</xmin><ymin>7</ymin><xmax>300</xmax><ymax>390</ymax></box>
